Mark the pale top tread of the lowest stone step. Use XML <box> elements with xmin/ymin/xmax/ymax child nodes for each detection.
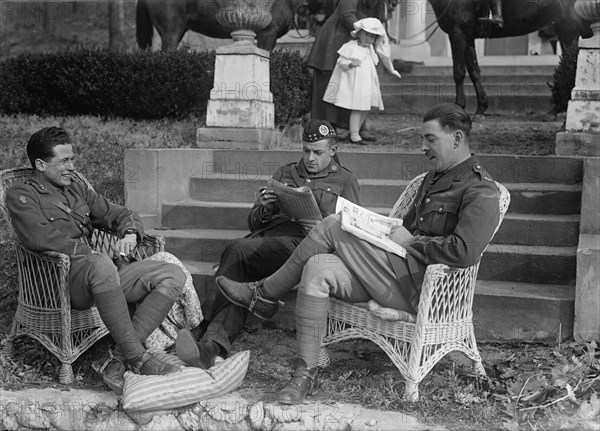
<box><xmin>182</xmin><ymin>260</ymin><xmax>575</xmax><ymax>301</ymax></box>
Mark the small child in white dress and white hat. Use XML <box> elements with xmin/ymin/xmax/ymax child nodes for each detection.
<box><xmin>323</xmin><ymin>18</ymin><xmax>400</xmax><ymax>144</ymax></box>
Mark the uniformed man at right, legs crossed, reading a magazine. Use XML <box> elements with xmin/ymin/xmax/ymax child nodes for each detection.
<box><xmin>216</xmin><ymin>103</ymin><xmax>500</xmax><ymax>404</ymax></box>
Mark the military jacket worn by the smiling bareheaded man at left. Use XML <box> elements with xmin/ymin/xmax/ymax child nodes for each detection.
<box><xmin>6</xmin><ymin>171</ymin><xmax>144</xmax><ymax>256</ymax></box>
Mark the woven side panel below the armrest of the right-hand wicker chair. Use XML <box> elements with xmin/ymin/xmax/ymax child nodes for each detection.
<box><xmin>417</xmin><ymin>263</ymin><xmax>479</xmax><ymax>324</ymax></box>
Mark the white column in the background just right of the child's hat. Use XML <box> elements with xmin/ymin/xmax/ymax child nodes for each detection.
<box><xmin>388</xmin><ymin>0</ymin><xmax>431</xmax><ymax>63</ymax></box>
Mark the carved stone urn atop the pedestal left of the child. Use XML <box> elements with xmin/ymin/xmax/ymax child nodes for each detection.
<box><xmin>216</xmin><ymin>0</ymin><xmax>272</xmax><ymax>44</ymax></box>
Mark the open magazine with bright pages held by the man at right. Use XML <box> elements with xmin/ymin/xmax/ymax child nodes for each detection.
<box><xmin>335</xmin><ymin>197</ymin><xmax>406</xmax><ymax>257</ymax></box>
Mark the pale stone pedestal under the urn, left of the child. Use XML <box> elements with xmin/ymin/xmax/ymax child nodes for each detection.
<box><xmin>196</xmin><ymin>43</ymin><xmax>279</xmax><ymax>149</ymax></box>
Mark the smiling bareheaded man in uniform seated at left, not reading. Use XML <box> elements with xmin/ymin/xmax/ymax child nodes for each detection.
<box><xmin>6</xmin><ymin>127</ymin><xmax>185</xmax><ymax>393</ymax></box>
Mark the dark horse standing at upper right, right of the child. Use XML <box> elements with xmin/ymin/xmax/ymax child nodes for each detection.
<box><xmin>429</xmin><ymin>0</ymin><xmax>592</xmax><ymax>114</ymax></box>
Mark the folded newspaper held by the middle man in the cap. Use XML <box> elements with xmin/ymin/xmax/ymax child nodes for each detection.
<box><xmin>269</xmin><ymin>179</ymin><xmax>323</xmax><ymax>220</ymax></box>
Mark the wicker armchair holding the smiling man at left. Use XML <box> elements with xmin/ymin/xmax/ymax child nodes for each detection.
<box><xmin>0</xmin><ymin>168</ymin><xmax>164</xmax><ymax>384</ymax></box>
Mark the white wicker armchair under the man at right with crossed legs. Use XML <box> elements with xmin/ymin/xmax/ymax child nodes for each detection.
<box><xmin>319</xmin><ymin>174</ymin><xmax>510</xmax><ymax>401</ymax></box>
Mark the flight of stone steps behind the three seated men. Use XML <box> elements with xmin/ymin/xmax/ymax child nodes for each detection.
<box><xmin>150</xmin><ymin>150</ymin><xmax>582</xmax><ymax>341</ymax></box>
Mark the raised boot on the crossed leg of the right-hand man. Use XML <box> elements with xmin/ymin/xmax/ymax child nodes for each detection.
<box><xmin>215</xmin><ymin>275</ymin><xmax>281</xmax><ymax>320</ymax></box>
